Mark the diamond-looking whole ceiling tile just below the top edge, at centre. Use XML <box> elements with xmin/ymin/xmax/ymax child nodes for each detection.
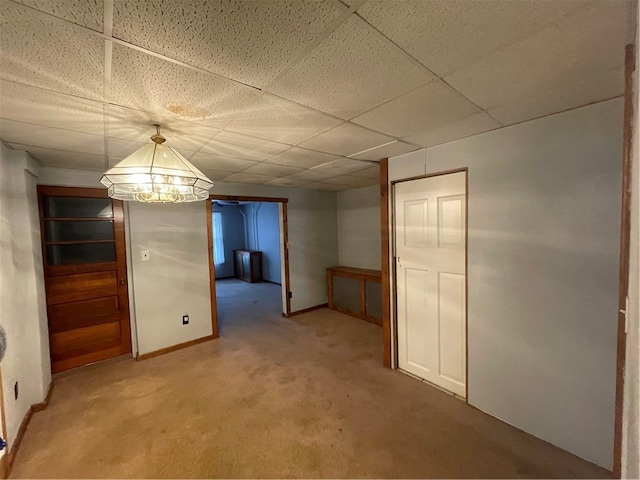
<box><xmin>267</xmin><ymin>15</ymin><xmax>433</xmax><ymax>119</ymax></box>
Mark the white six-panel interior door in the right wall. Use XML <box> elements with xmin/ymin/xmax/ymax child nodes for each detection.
<box><xmin>394</xmin><ymin>172</ymin><xmax>466</xmax><ymax>397</ymax></box>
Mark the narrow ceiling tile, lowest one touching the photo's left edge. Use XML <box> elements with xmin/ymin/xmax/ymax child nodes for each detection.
<box><xmin>0</xmin><ymin>119</ymin><xmax>104</xmax><ymax>155</ymax></box>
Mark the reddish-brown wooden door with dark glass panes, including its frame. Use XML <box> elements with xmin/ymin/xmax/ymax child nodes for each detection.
<box><xmin>38</xmin><ymin>186</ymin><xmax>131</xmax><ymax>373</ymax></box>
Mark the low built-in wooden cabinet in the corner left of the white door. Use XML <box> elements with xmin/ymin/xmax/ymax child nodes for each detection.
<box><xmin>327</xmin><ymin>267</ymin><xmax>382</xmax><ymax>325</ymax></box>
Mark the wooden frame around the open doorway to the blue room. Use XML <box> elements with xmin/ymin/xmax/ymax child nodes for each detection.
<box><xmin>206</xmin><ymin>195</ymin><xmax>291</xmax><ymax>337</ymax></box>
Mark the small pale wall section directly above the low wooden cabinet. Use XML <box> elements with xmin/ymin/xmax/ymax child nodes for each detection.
<box><xmin>337</xmin><ymin>185</ymin><xmax>381</xmax><ymax>270</ymax></box>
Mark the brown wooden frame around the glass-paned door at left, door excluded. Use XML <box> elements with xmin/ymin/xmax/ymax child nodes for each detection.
<box><xmin>37</xmin><ymin>185</ymin><xmax>133</xmax><ymax>373</ymax></box>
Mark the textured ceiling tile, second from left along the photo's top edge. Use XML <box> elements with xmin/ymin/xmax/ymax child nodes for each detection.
<box><xmin>113</xmin><ymin>0</ymin><xmax>343</xmax><ymax>86</ymax></box>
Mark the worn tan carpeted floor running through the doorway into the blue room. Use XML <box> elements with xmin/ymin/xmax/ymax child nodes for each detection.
<box><xmin>11</xmin><ymin>281</ymin><xmax>608</xmax><ymax>478</ymax></box>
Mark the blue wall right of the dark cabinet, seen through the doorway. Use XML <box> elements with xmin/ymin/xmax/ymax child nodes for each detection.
<box><xmin>243</xmin><ymin>202</ymin><xmax>282</xmax><ymax>283</ymax></box>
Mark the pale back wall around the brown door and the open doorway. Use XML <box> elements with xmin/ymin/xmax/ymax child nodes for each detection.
<box><xmin>38</xmin><ymin>167</ymin><xmax>338</xmax><ymax>344</ymax></box>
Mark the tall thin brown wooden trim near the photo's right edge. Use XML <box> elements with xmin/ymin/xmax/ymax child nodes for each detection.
<box><xmin>613</xmin><ymin>44</ymin><xmax>636</xmax><ymax>478</ymax></box>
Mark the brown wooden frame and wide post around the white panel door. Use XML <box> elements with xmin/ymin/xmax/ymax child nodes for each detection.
<box><xmin>380</xmin><ymin>167</ymin><xmax>469</xmax><ymax>403</ymax></box>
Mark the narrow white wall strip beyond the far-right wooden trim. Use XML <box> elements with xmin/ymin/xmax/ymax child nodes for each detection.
<box><xmin>622</xmin><ymin>21</ymin><xmax>640</xmax><ymax>478</ymax></box>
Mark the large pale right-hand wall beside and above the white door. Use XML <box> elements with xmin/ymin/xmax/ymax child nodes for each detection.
<box><xmin>389</xmin><ymin>99</ymin><xmax>622</xmax><ymax>469</ymax></box>
